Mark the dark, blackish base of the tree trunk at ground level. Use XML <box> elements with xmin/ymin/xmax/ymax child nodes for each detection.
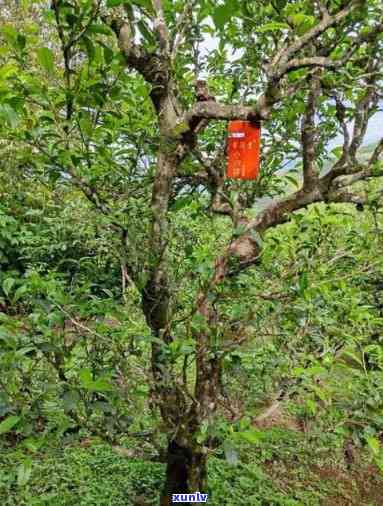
<box><xmin>160</xmin><ymin>441</ymin><xmax>207</xmax><ymax>506</ymax></box>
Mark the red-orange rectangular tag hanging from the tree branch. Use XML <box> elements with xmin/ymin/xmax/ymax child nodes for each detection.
<box><xmin>227</xmin><ymin>121</ymin><xmax>261</xmax><ymax>179</ymax></box>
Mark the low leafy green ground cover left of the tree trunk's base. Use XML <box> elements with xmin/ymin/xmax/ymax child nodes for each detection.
<box><xmin>0</xmin><ymin>445</ymin><xmax>163</xmax><ymax>506</ymax></box>
